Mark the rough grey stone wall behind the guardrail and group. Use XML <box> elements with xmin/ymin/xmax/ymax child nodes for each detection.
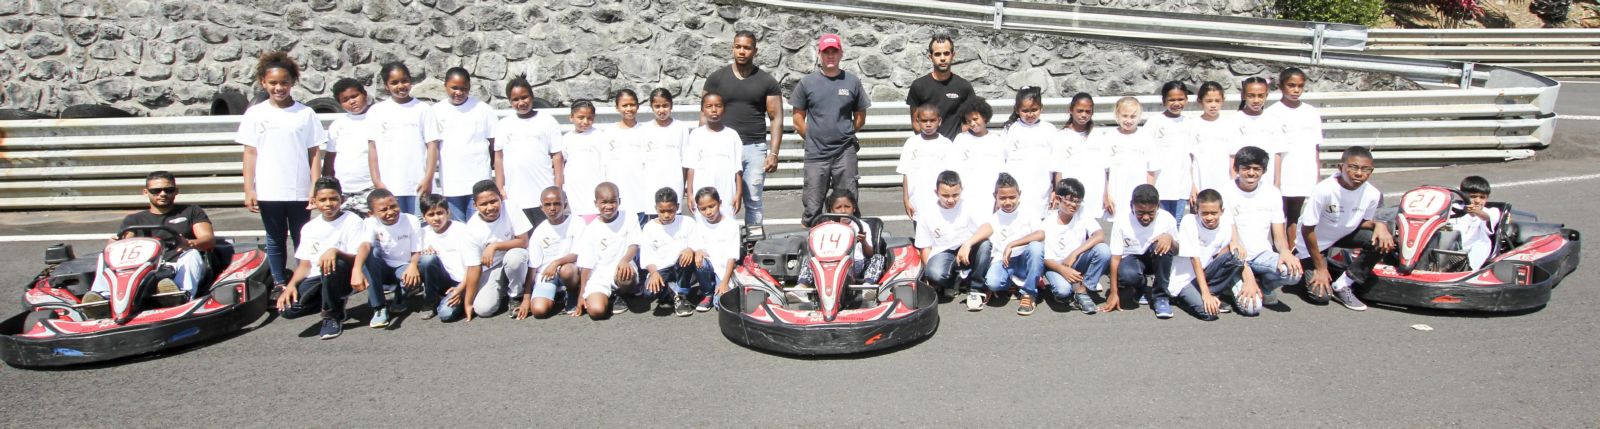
<box><xmin>0</xmin><ymin>0</ymin><xmax>1413</xmax><ymax>115</ymax></box>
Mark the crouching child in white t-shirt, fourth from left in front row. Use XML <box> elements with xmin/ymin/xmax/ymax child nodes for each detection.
<box><xmin>450</xmin><ymin>181</ymin><xmax>533</xmax><ymax>322</ymax></box>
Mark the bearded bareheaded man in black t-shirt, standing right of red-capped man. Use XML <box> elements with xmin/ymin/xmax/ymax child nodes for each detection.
<box><xmin>906</xmin><ymin>34</ymin><xmax>973</xmax><ymax>139</ymax></box>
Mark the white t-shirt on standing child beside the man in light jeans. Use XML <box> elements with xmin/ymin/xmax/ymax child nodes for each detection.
<box><xmin>683</xmin><ymin>126</ymin><xmax>744</xmax><ymax>218</ymax></box>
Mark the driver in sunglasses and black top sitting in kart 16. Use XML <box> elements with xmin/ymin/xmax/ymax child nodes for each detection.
<box><xmin>83</xmin><ymin>171</ymin><xmax>216</xmax><ymax>303</ymax></box>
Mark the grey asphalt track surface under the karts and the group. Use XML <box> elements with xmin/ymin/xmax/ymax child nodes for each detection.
<box><xmin>0</xmin><ymin>83</ymin><xmax>1600</xmax><ymax>427</ymax></box>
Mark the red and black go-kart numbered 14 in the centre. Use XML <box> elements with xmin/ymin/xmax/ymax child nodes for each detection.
<box><xmin>717</xmin><ymin>215</ymin><xmax>939</xmax><ymax>355</ymax></box>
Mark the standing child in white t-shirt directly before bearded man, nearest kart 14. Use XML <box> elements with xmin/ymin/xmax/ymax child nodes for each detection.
<box><xmin>894</xmin><ymin>104</ymin><xmax>954</xmax><ymax>218</ymax></box>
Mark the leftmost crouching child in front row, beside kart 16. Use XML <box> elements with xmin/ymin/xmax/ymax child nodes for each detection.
<box><xmin>278</xmin><ymin>178</ymin><xmax>363</xmax><ymax>339</ymax></box>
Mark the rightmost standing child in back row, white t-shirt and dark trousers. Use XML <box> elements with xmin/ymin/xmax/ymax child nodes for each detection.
<box><xmin>1266</xmin><ymin>67</ymin><xmax>1324</xmax><ymax>251</ymax></box>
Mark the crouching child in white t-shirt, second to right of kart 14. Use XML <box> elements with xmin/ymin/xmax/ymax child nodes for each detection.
<box><xmin>966</xmin><ymin>173</ymin><xmax>1045</xmax><ymax>315</ymax></box>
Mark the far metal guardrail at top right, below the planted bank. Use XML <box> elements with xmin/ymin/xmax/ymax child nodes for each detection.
<box><xmin>1366</xmin><ymin>29</ymin><xmax>1600</xmax><ymax>77</ymax></box>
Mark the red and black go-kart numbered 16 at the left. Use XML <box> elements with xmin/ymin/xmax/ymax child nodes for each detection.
<box><xmin>0</xmin><ymin>226</ymin><xmax>272</xmax><ymax>367</ymax></box>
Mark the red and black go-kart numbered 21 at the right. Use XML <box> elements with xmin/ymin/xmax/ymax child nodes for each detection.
<box><xmin>1334</xmin><ymin>186</ymin><xmax>1582</xmax><ymax>312</ymax></box>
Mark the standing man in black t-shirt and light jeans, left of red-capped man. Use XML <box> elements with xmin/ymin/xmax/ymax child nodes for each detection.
<box><xmin>701</xmin><ymin>30</ymin><xmax>784</xmax><ymax>226</ymax></box>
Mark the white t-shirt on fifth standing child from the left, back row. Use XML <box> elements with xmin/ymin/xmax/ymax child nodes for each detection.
<box><xmin>494</xmin><ymin>110</ymin><xmax>571</xmax><ymax>206</ymax></box>
